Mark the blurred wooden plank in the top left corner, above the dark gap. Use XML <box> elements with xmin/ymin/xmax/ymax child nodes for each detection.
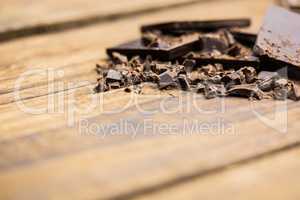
<box><xmin>0</xmin><ymin>0</ymin><xmax>204</xmax><ymax>41</ymax></box>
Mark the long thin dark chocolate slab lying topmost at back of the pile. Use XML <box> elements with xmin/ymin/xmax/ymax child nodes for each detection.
<box><xmin>141</xmin><ymin>19</ymin><xmax>251</xmax><ymax>34</ymax></box>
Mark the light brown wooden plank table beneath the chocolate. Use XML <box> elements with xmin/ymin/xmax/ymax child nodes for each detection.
<box><xmin>0</xmin><ymin>0</ymin><xmax>300</xmax><ymax>200</ymax></box>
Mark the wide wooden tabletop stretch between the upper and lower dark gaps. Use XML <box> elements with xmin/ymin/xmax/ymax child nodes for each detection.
<box><xmin>0</xmin><ymin>0</ymin><xmax>300</xmax><ymax>199</ymax></box>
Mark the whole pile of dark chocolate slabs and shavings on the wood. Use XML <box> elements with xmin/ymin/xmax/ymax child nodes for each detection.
<box><xmin>95</xmin><ymin>6</ymin><xmax>300</xmax><ymax>100</ymax></box>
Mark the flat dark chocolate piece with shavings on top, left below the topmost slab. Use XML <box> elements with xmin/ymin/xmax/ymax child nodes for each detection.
<box><xmin>106</xmin><ymin>34</ymin><xmax>198</xmax><ymax>61</ymax></box>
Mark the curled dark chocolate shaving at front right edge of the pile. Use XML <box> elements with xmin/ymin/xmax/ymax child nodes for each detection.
<box><xmin>227</xmin><ymin>84</ymin><xmax>264</xmax><ymax>100</ymax></box>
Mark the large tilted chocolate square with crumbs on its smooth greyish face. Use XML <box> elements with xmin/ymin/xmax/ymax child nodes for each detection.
<box><xmin>254</xmin><ymin>6</ymin><xmax>300</xmax><ymax>67</ymax></box>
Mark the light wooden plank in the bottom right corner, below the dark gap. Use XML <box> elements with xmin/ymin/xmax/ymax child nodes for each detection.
<box><xmin>137</xmin><ymin>147</ymin><xmax>300</xmax><ymax>200</ymax></box>
